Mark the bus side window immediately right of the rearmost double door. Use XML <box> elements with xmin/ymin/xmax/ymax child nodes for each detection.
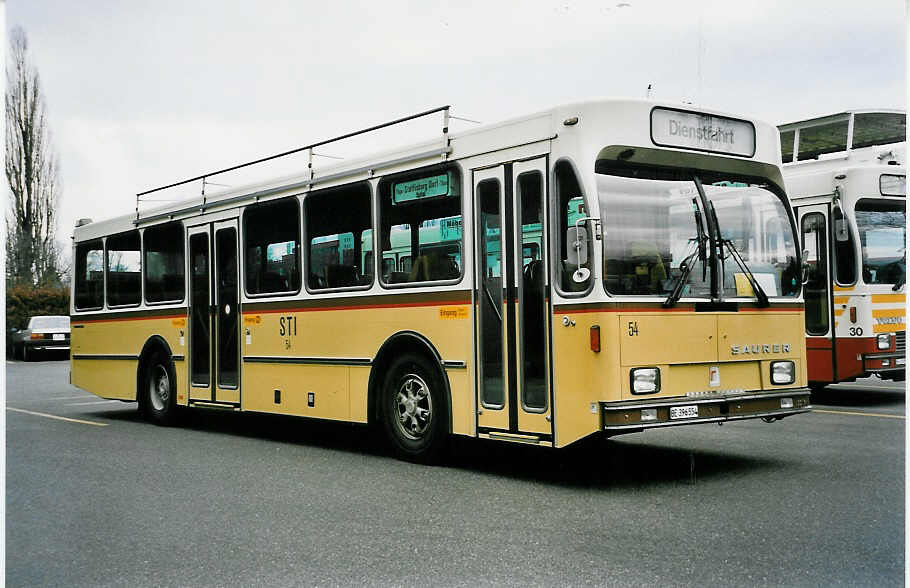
<box><xmin>243</xmin><ymin>198</ymin><xmax>300</xmax><ymax>294</ymax></box>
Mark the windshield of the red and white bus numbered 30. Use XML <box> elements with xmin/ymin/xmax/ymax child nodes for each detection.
<box><xmin>855</xmin><ymin>198</ymin><xmax>907</xmax><ymax>284</ymax></box>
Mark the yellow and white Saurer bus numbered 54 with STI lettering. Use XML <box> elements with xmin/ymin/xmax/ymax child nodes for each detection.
<box><xmin>71</xmin><ymin>100</ymin><xmax>809</xmax><ymax>460</ymax></box>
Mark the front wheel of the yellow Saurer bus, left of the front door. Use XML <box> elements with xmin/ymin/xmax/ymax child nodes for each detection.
<box><xmin>381</xmin><ymin>354</ymin><xmax>449</xmax><ymax>464</ymax></box>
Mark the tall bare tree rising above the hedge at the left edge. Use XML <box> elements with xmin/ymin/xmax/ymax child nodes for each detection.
<box><xmin>6</xmin><ymin>27</ymin><xmax>62</xmax><ymax>285</ymax></box>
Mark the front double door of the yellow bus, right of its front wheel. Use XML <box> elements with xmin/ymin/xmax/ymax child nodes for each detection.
<box><xmin>473</xmin><ymin>157</ymin><xmax>553</xmax><ymax>438</ymax></box>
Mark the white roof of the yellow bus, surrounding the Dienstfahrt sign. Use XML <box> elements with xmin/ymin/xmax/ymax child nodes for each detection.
<box><xmin>73</xmin><ymin>98</ymin><xmax>780</xmax><ymax>241</ymax></box>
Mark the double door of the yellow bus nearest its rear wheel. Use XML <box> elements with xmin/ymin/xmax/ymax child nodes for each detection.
<box><xmin>187</xmin><ymin>219</ymin><xmax>240</xmax><ymax>405</ymax></box>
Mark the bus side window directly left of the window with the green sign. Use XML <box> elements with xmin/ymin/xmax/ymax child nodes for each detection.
<box><xmin>303</xmin><ymin>182</ymin><xmax>374</xmax><ymax>290</ymax></box>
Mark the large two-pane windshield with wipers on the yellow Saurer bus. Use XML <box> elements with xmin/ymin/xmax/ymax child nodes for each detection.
<box><xmin>597</xmin><ymin>174</ymin><xmax>799</xmax><ymax>298</ymax></box>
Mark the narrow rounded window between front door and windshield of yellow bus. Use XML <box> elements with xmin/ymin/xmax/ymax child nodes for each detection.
<box><xmin>555</xmin><ymin>161</ymin><xmax>593</xmax><ymax>292</ymax></box>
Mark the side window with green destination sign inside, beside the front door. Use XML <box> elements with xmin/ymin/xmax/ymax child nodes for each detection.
<box><xmin>379</xmin><ymin>167</ymin><xmax>463</xmax><ymax>284</ymax></box>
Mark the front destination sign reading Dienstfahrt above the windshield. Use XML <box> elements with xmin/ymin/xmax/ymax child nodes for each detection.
<box><xmin>651</xmin><ymin>108</ymin><xmax>755</xmax><ymax>157</ymax></box>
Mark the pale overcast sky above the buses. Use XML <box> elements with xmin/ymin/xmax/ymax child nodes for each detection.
<box><xmin>6</xmin><ymin>0</ymin><xmax>907</xmax><ymax>253</ymax></box>
